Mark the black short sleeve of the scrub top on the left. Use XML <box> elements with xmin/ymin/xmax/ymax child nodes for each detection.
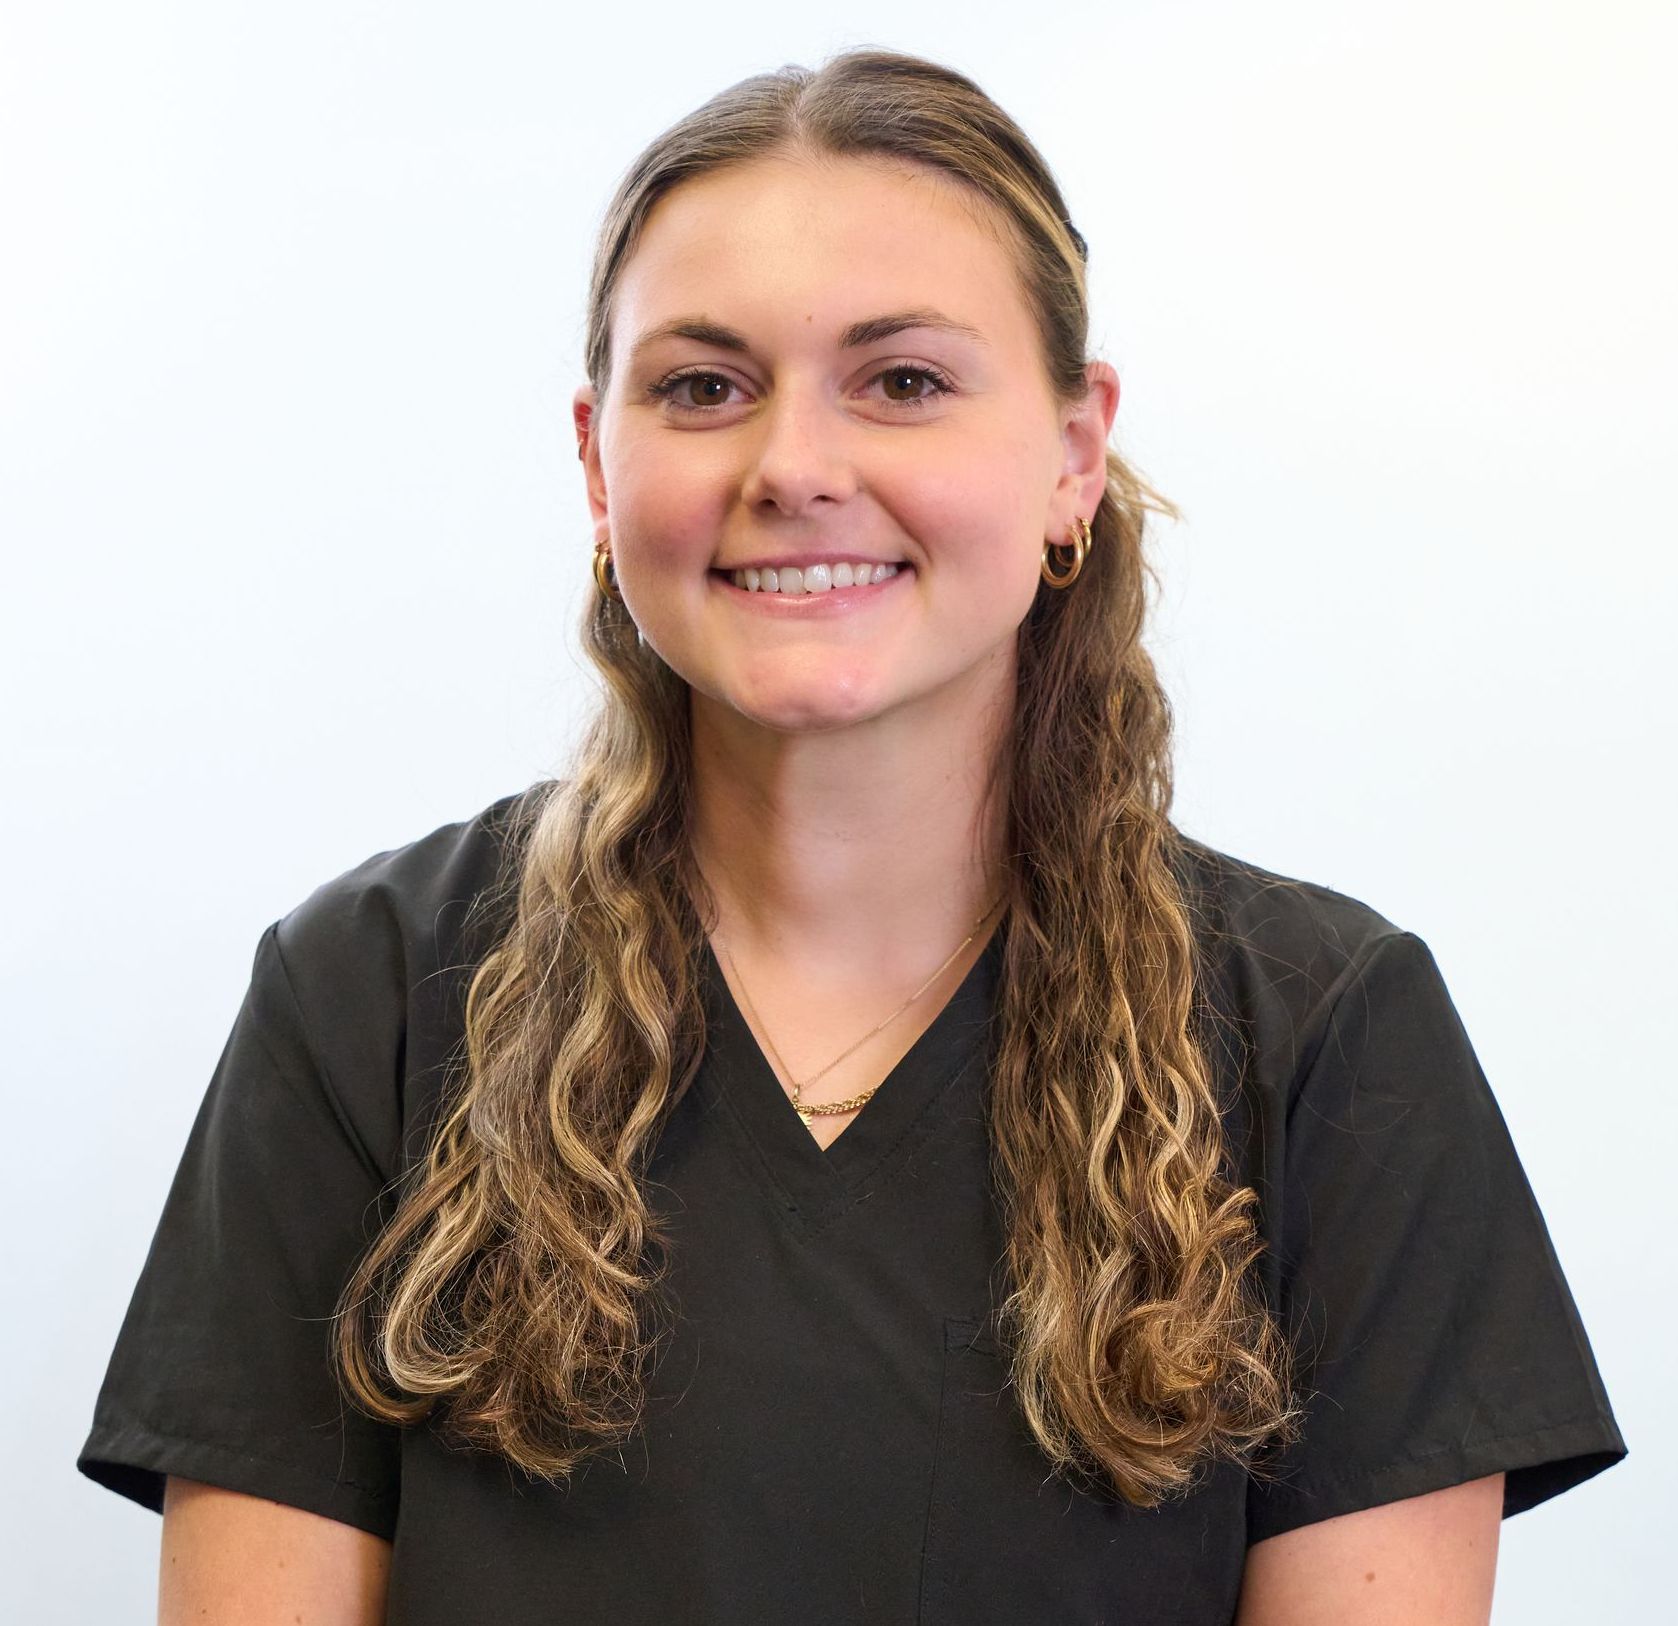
<box><xmin>77</xmin><ymin>923</ymin><xmax>399</xmax><ymax>1539</ymax></box>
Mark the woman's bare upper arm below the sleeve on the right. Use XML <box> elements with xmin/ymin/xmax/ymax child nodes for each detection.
<box><xmin>1235</xmin><ymin>1473</ymin><xmax>1503</xmax><ymax>1626</ymax></box>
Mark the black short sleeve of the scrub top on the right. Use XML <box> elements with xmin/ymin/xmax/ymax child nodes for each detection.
<box><xmin>1247</xmin><ymin>933</ymin><xmax>1626</xmax><ymax>1542</ymax></box>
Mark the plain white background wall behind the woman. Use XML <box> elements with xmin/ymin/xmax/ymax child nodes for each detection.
<box><xmin>0</xmin><ymin>0</ymin><xmax>1678</xmax><ymax>1626</ymax></box>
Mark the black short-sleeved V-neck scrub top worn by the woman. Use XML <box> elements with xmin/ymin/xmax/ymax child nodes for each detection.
<box><xmin>79</xmin><ymin>781</ymin><xmax>1626</xmax><ymax>1626</ymax></box>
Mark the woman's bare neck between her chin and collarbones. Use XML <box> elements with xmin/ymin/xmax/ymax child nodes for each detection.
<box><xmin>691</xmin><ymin>693</ymin><xmax>1005</xmax><ymax>983</ymax></box>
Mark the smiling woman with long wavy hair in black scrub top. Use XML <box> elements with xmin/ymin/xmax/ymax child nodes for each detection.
<box><xmin>81</xmin><ymin>50</ymin><xmax>1624</xmax><ymax>1626</ymax></box>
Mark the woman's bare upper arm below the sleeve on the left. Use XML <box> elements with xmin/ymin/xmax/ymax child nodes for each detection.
<box><xmin>158</xmin><ymin>1475</ymin><xmax>391</xmax><ymax>1626</ymax></box>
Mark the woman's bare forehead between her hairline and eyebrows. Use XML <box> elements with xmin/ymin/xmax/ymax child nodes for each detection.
<box><xmin>612</xmin><ymin>156</ymin><xmax>1035</xmax><ymax>354</ymax></box>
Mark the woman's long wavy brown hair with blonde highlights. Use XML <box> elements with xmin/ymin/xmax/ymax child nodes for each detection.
<box><xmin>336</xmin><ymin>49</ymin><xmax>1299</xmax><ymax>1507</ymax></box>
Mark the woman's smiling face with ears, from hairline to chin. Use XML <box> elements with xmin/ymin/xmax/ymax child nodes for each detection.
<box><xmin>576</xmin><ymin>158</ymin><xmax>1118</xmax><ymax>732</ymax></box>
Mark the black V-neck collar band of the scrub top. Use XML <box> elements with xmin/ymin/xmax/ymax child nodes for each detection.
<box><xmin>701</xmin><ymin>921</ymin><xmax>1007</xmax><ymax>1225</ymax></box>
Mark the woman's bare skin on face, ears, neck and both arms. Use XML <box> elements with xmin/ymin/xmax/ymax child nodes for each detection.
<box><xmin>159</xmin><ymin>145</ymin><xmax>1502</xmax><ymax>1626</ymax></box>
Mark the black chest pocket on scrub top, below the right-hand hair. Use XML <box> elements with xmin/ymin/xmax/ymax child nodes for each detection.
<box><xmin>920</xmin><ymin>1321</ymin><xmax>1247</xmax><ymax>1626</ymax></box>
